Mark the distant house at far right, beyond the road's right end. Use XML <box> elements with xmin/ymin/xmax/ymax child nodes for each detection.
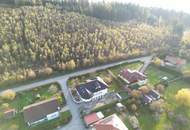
<box><xmin>164</xmin><ymin>55</ymin><xmax>187</xmax><ymax>67</ymax></box>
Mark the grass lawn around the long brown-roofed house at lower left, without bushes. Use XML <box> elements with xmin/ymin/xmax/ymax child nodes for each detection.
<box><xmin>0</xmin><ymin>83</ymin><xmax>71</xmax><ymax>130</ymax></box>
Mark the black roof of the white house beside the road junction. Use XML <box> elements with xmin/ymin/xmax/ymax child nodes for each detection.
<box><xmin>76</xmin><ymin>78</ymin><xmax>108</xmax><ymax>99</ymax></box>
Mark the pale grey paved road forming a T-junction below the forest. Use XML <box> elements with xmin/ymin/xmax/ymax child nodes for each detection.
<box><xmin>0</xmin><ymin>56</ymin><xmax>153</xmax><ymax>130</ymax></box>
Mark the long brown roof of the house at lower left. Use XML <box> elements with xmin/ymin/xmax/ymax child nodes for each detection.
<box><xmin>23</xmin><ymin>97</ymin><xmax>61</xmax><ymax>123</ymax></box>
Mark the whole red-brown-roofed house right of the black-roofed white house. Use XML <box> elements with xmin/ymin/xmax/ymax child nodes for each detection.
<box><xmin>119</xmin><ymin>69</ymin><xmax>147</xmax><ymax>86</ymax></box>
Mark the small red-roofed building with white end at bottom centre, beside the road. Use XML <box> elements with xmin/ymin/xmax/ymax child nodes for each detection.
<box><xmin>84</xmin><ymin>112</ymin><xmax>104</xmax><ymax>127</ymax></box>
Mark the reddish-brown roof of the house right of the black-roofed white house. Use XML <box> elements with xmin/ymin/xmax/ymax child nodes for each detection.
<box><xmin>121</xmin><ymin>69</ymin><xmax>146</xmax><ymax>83</ymax></box>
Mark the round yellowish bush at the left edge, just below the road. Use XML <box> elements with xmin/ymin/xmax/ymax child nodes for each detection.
<box><xmin>0</xmin><ymin>89</ymin><xmax>16</xmax><ymax>100</ymax></box>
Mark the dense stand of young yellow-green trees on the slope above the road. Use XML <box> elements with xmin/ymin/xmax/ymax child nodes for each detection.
<box><xmin>0</xmin><ymin>0</ymin><xmax>189</xmax><ymax>87</ymax></box>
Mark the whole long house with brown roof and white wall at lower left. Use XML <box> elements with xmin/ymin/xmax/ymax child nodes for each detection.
<box><xmin>23</xmin><ymin>97</ymin><xmax>61</xmax><ymax>126</ymax></box>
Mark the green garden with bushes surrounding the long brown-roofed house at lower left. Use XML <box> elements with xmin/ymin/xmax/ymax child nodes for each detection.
<box><xmin>0</xmin><ymin>83</ymin><xmax>72</xmax><ymax>130</ymax></box>
